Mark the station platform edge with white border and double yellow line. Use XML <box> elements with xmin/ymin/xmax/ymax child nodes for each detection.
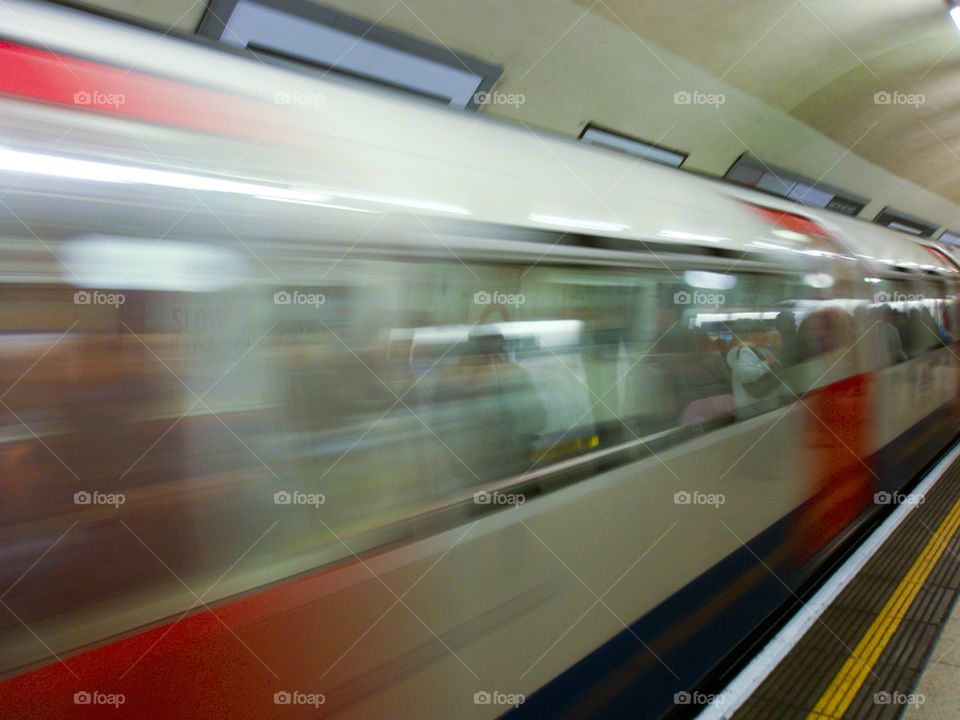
<box><xmin>699</xmin><ymin>445</ymin><xmax>960</xmax><ymax>720</ymax></box>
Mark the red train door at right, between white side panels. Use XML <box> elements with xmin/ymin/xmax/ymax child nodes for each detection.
<box><xmin>744</xmin><ymin>208</ymin><xmax>874</xmax><ymax>564</ymax></box>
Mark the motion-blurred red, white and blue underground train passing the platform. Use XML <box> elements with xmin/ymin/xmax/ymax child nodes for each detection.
<box><xmin>0</xmin><ymin>0</ymin><xmax>960</xmax><ymax>720</ymax></box>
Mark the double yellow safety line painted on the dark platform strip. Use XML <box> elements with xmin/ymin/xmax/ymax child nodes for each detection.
<box><xmin>807</xmin><ymin>500</ymin><xmax>960</xmax><ymax>720</ymax></box>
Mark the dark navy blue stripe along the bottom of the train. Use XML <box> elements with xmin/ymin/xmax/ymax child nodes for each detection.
<box><xmin>503</xmin><ymin>403</ymin><xmax>958</xmax><ymax>720</ymax></box>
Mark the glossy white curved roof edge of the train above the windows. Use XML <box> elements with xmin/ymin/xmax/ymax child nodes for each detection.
<box><xmin>0</xmin><ymin>0</ymin><xmax>784</xmax><ymax>252</ymax></box>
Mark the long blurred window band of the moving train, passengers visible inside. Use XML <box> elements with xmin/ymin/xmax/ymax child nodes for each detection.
<box><xmin>0</xmin><ymin>259</ymin><xmax>928</xmax><ymax>669</ymax></box>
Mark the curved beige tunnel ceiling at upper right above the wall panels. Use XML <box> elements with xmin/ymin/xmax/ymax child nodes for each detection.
<box><xmin>576</xmin><ymin>0</ymin><xmax>960</xmax><ymax>205</ymax></box>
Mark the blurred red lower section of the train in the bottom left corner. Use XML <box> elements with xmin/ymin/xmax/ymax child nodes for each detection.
<box><xmin>0</xmin><ymin>562</ymin><xmax>372</xmax><ymax>720</ymax></box>
